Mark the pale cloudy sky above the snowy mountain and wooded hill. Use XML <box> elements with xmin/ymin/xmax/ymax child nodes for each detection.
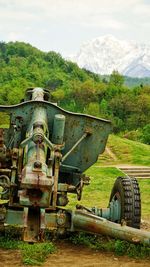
<box><xmin>0</xmin><ymin>0</ymin><xmax>150</xmax><ymax>56</ymax></box>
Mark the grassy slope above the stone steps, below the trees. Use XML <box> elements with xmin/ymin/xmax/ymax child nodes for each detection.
<box><xmin>98</xmin><ymin>135</ymin><xmax>150</xmax><ymax>166</ymax></box>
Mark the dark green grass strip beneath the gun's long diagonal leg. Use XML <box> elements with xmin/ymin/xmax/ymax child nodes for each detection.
<box><xmin>70</xmin><ymin>233</ymin><xmax>150</xmax><ymax>259</ymax></box>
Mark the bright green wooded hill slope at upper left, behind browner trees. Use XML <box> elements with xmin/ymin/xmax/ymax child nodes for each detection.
<box><xmin>0</xmin><ymin>42</ymin><xmax>99</xmax><ymax>104</ymax></box>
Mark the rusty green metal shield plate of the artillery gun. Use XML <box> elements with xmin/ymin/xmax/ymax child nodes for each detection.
<box><xmin>0</xmin><ymin>100</ymin><xmax>111</xmax><ymax>172</ymax></box>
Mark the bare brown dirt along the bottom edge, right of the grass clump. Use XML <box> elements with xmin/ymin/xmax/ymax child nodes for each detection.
<box><xmin>44</xmin><ymin>243</ymin><xmax>150</xmax><ymax>267</ymax></box>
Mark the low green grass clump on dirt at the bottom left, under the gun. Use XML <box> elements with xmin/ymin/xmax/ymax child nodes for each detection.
<box><xmin>0</xmin><ymin>238</ymin><xmax>56</xmax><ymax>265</ymax></box>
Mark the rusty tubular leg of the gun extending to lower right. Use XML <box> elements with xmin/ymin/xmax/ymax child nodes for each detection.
<box><xmin>72</xmin><ymin>211</ymin><xmax>150</xmax><ymax>245</ymax></box>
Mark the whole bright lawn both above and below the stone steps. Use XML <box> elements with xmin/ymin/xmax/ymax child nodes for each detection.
<box><xmin>69</xmin><ymin>135</ymin><xmax>150</xmax><ymax>219</ymax></box>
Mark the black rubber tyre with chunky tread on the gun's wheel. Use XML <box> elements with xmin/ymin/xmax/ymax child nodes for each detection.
<box><xmin>109</xmin><ymin>177</ymin><xmax>141</xmax><ymax>228</ymax></box>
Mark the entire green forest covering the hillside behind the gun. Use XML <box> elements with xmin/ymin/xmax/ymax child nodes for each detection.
<box><xmin>0</xmin><ymin>42</ymin><xmax>150</xmax><ymax>144</ymax></box>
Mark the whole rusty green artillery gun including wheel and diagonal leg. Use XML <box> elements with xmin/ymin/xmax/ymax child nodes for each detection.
<box><xmin>0</xmin><ymin>88</ymin><xmax>150</xmax><ymax>245</ymax></box>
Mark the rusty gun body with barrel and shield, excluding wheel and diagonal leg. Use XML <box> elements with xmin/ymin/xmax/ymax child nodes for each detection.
<box><xmin>0</xmin><ymin>88</ymin><xmax>117</xmax><ymax>242</ymax></box>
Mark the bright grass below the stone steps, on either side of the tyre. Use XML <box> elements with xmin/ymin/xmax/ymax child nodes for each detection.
<box><xmin>67</xmin><ymin>168</ymin><xmax>150</xmax><ymax>218</ymax></box>
